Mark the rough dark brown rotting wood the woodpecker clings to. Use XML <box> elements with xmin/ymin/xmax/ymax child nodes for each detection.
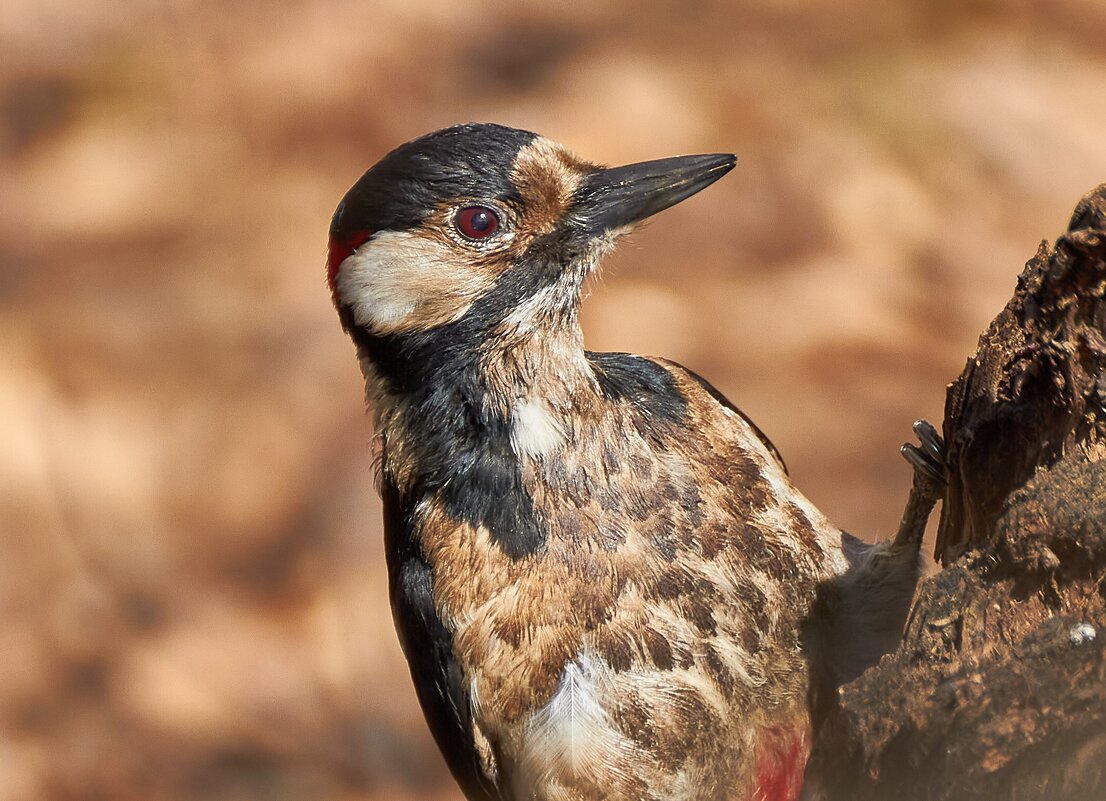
<box><xmin>806</xmin><ymin>185</ymin><xmax>1106</xmax><ymax>801</ymax></box>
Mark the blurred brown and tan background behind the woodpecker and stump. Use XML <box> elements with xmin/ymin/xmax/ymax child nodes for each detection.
<box><xmin>0</xmin><ymin>0</ymin><xmax>1106</xmax><ymax>801</ymax></box>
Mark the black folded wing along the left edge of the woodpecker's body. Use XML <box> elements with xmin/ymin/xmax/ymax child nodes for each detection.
<box><xmin>380</xmin><ymin>478</ymin><xmax>499</xmax><ymax>801</ymax></box>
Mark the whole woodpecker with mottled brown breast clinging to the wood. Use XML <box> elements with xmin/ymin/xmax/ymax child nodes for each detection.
<box><xmin>327</xmin><ymin>124</ymin><xmax>940</xmax><ymax>801</ymax></box>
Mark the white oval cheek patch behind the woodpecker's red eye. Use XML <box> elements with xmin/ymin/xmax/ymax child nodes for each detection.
<box><xmin>337</xmin><ymin>231</ymin><xmax>488</xmax><ymax>333</ymax></box>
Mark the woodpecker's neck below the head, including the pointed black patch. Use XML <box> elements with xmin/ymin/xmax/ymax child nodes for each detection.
<box><xmin>355</xmin><ymin>316</ymin><xmax>597</xmax><ymax>559</ymax></box>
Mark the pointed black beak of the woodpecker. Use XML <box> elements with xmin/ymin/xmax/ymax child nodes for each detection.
<box><xmin>572</xmin><ymin>153</ymin><xmax>738</xmax><ymax>236</ymax></box>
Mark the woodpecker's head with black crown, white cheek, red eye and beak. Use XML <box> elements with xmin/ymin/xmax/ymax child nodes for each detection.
<box><xmin>327</xmin><ymin>124</ymin><xmax>734</xmax><ymax>387</ymax></box>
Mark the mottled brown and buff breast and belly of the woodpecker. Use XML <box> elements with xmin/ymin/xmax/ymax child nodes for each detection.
<box><xmin>402</xmin><ymin>360</ymin><xmax>846</xmax><ymax>801</ymax></box>
